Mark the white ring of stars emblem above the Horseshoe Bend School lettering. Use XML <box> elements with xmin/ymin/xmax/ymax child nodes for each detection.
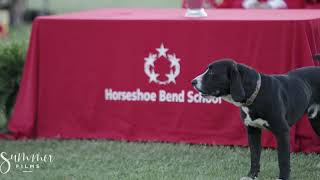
<box><xmin>144</xmin><ymin>43</ymin><xmax>180</xmax><ymax>85</ymax></box>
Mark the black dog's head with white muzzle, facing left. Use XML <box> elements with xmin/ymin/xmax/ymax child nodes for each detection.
<box><xmin>192</xmin><ymin>59</ymin><xmax>245</xmax><ymax>102</ymax></box>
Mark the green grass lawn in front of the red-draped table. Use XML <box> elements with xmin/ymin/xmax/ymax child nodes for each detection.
<box><xmin>0</xmin><ymin>140</ymin><xmax>320</xmax><ymax>180</ymax></box>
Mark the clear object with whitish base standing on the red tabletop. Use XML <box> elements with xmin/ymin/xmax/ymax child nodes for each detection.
<box><xmin>185</xmin><ymin>0</ymin><xmax>208</xmax><ymax>17</ymax></box>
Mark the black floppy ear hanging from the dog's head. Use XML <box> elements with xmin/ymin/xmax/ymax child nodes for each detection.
<box><xmin>229</xmin><ymin>63</ymin><xmax>245</xmax><ymax>102</ymax></box>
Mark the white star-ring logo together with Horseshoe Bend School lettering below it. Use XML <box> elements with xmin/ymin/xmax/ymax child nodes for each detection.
<box><xmin>104</xmin><ymin>43</ymin><xmax>222</xmax><ymax>104</ymax></box>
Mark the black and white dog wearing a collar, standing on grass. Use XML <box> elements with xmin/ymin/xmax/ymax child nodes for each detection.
<box><xmin>192</xmin><ymin>56</ymin><xmax>320</xmax><ymax>180</ymax></box>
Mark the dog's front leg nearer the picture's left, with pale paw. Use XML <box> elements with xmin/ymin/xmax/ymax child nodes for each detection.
<box><xmin>241</xmin><ymin>126</ymin><xmax>261</xmax><ymax>180</ymax></box>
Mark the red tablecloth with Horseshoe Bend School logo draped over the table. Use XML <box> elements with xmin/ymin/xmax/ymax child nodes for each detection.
<box><xmin>9</xmin><ymin>9</ymin><xmax>320</xmax><ymax>152</ymax></box>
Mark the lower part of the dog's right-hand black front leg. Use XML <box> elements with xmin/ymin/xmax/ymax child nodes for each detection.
<box><xmin>275</xmin><ymin>130</ymin><xmax>290</xmax><ymax>180</ymax></box>
